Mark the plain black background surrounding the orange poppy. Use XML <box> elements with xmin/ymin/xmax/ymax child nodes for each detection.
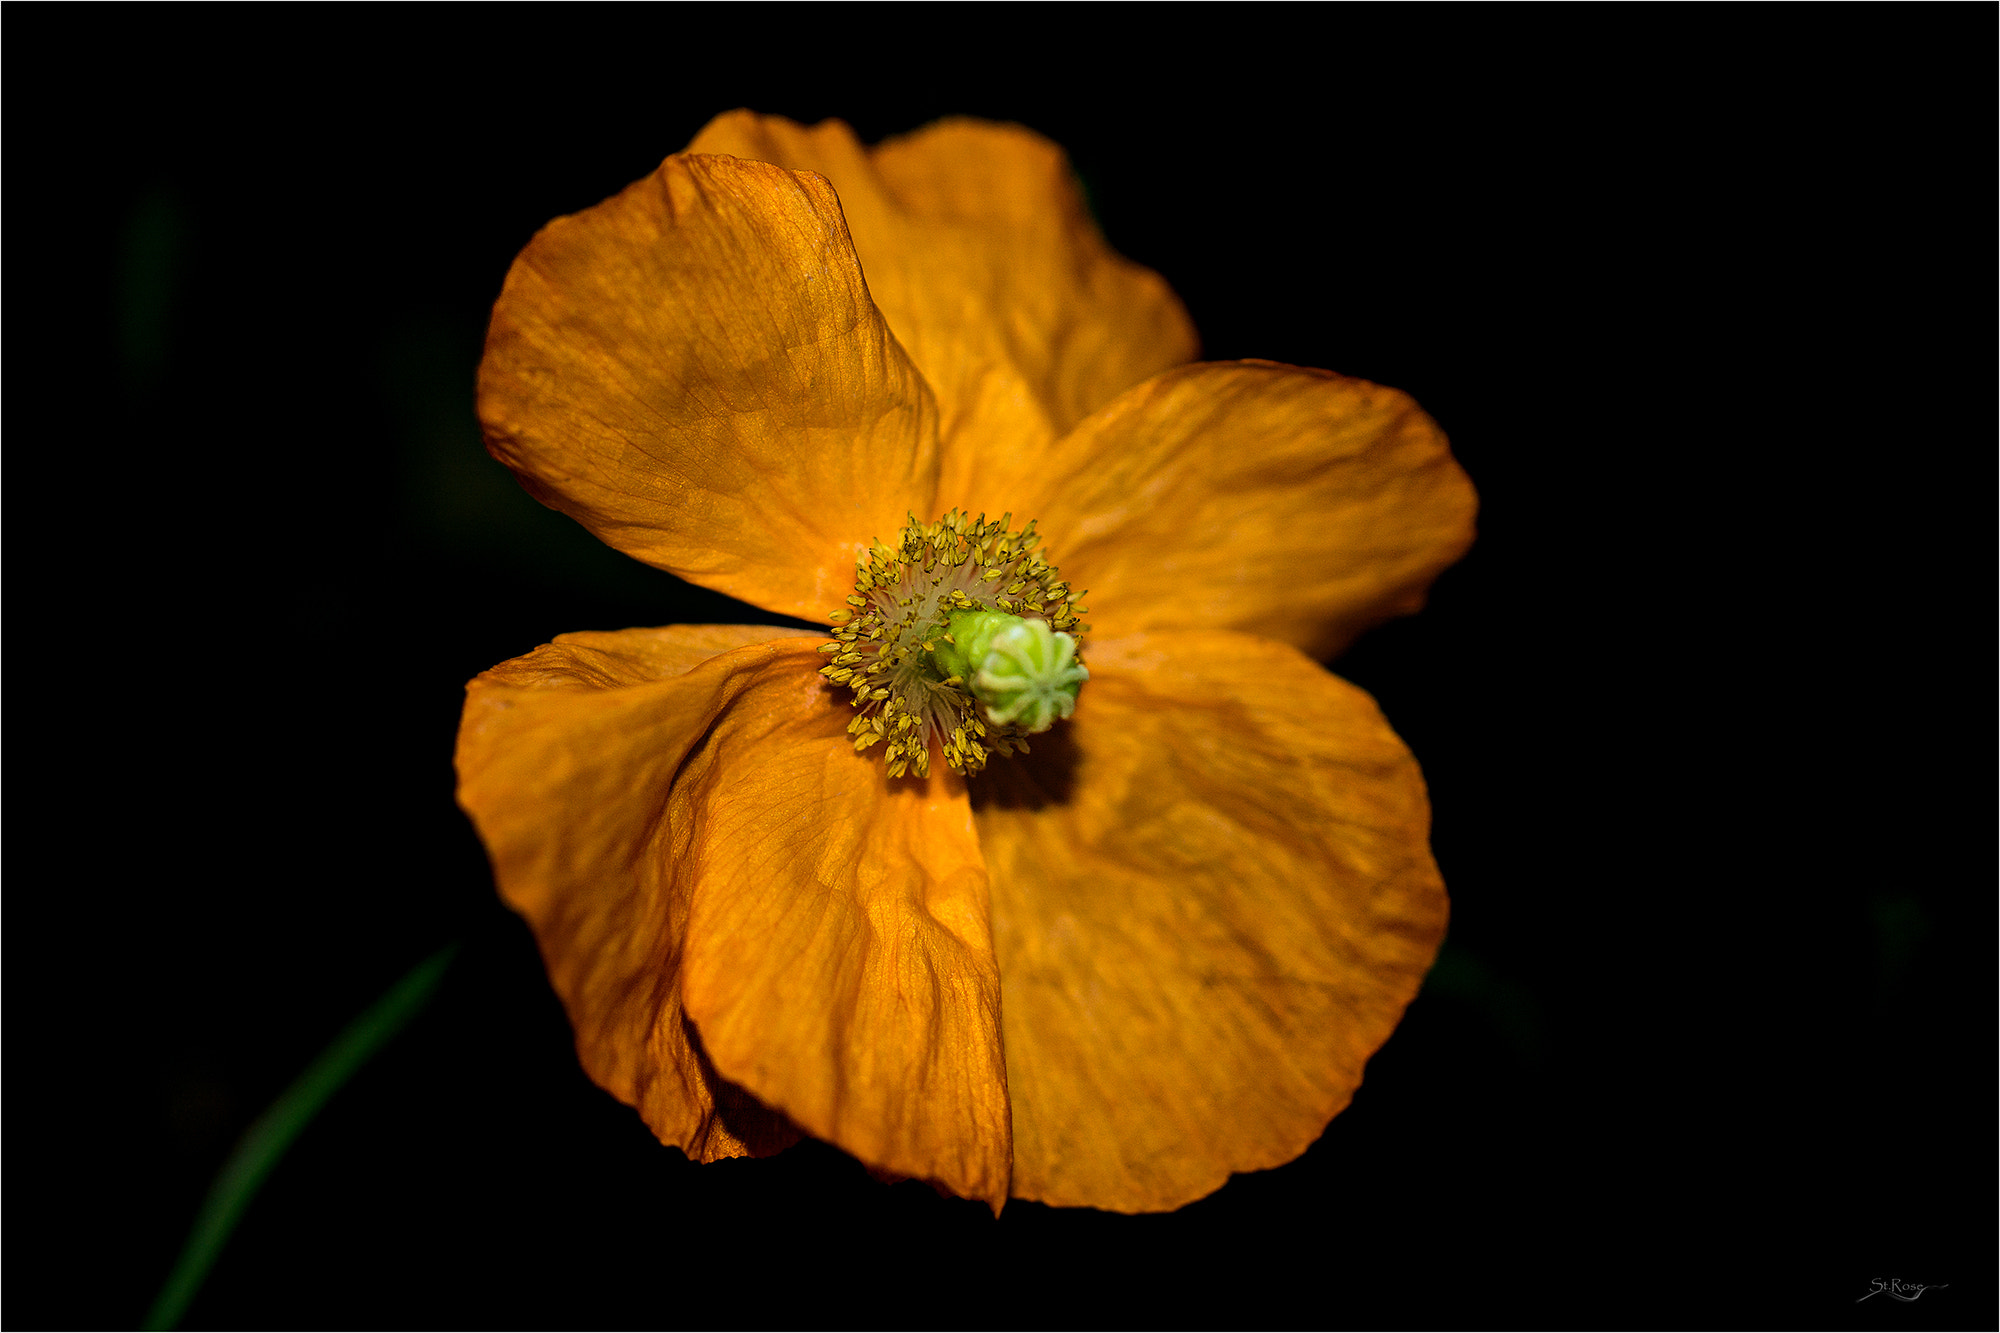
<box><xmin>0</xmin><ymin>6</ymin><xmax>1996</xmax><ymax>1327</ymax></box>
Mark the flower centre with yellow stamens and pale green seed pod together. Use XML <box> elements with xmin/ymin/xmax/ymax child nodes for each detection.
<box><xmin>820</xmin><ymin>508</ymin><xmax>1090</xmax><ymax>777</ymax></box>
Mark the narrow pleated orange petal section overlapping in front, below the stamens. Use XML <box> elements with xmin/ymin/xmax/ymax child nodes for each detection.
<box><xmin>668</xmin><ymin>652</ymin><xmax>1012</xmax><ymax>1213</ymax></box>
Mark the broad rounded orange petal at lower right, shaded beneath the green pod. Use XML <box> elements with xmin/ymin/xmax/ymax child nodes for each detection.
<box><xmin>976</xmin><ymin>632</ymin><xmax>1446</xmax><ymax>1213</ymax></box>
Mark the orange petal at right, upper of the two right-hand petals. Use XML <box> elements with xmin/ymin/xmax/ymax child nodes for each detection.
<box><xmin>1008</xmin><ymin>360</ymin><xmax>1478</xmax><ymax>658</ymax></box>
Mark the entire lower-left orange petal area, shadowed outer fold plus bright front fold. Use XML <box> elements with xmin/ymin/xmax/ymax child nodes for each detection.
<box><xmin>458</xmin><ymin>626</ymin><xmax>1010</xmax><ymax>1209</ymax></box>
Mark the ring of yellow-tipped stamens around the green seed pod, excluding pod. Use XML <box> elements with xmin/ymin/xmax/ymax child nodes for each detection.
<box><xmin>820</xmin><ymin>508</ymin><xmax>1088</xmax><ymax>777</ymax></box>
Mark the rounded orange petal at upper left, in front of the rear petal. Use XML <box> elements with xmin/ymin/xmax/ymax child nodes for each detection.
<box><xmin>480</xmin><ymin>156</ymin><xmax>938</xmax><ymax>618</ymax></box>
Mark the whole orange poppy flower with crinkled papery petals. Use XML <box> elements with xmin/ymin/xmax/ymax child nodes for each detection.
<box><xmin>458</xmin><ymin>112</ymin><xmax>1474</xmax><ymax>1211</ymax></box>
